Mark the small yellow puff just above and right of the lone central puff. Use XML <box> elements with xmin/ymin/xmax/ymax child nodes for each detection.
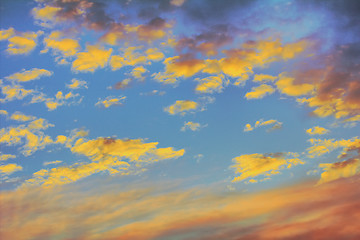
<box><xmin>195</xmin><ymin>74</ymin><xmax>229</xmax><ymax>93</ymax></box>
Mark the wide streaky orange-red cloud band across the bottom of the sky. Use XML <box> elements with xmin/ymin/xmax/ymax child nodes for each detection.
<box><xmin>0</xmin><ymin>176</ymin><xmax>360</xmax><ymax>240</ymax></box>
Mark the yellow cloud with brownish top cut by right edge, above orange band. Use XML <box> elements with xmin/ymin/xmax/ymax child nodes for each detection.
<box><xmin>318</xmin><ymin>159</ymin><xmax>360</xmax><ymax>185</ymax></box>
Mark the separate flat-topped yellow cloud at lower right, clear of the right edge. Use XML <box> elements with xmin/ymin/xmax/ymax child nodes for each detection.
<box><xmin>231</xmin><ymin>153</ymin><xmax>304</xmax><ymax>182</ymax></box>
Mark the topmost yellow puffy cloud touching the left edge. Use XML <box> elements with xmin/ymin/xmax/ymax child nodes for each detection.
<box><xmin>0</xmin><ymin>28</ymin><xmax>43</xmax><ymax>55</ymax></box>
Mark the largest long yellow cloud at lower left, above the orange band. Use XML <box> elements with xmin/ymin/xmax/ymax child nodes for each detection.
<box><xmin>25</xmin><ymin>138</ymin><xmax>185</xmax><ymax>187</ymax></box>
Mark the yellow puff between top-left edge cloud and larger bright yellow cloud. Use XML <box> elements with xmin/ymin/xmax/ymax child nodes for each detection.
<box><xmin>44</xmin><ymin>31</ymin><xmax>81</xmax><ymax>57</ymax></box>
